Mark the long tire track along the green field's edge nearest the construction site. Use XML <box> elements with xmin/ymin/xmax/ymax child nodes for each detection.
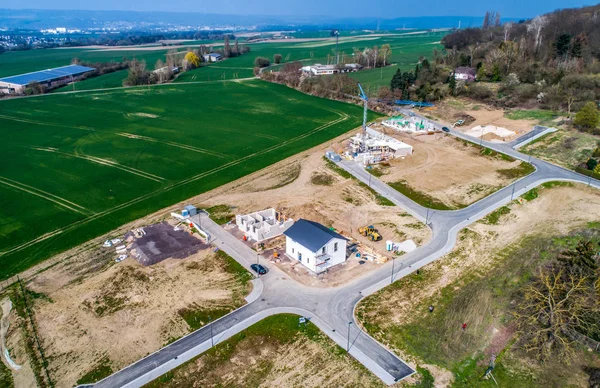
<box><xmin>0</xmin><ymin>110</ymin><xmax>350</xmax><ymax>257</ymax></box>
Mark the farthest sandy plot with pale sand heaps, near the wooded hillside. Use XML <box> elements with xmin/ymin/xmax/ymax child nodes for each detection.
<box><xmin>422</xmin><ymin>98</ymin><xmax>537</xmax><ymax>141</ymax></box>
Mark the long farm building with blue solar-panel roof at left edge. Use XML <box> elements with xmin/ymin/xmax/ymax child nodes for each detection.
<box><xmin>0</xmin><ymin>65</ymin><xmax>96</xmax><ymax>94</ymax></box>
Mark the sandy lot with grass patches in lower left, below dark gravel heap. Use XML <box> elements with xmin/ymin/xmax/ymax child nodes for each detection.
<box><xmin>28</xmin><ymin>250</ymin><xmax>247</xmax><ymax>387</ymax></box>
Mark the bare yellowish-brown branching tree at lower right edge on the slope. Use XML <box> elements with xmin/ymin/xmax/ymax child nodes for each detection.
<box><xmin>514</xmin><ymin>265</ymin><xmax>598</xmax><ymax>362</ymax></box>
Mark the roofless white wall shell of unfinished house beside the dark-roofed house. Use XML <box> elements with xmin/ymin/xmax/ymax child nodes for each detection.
<box><xmin>235</xmin><ymin>209</ymin><xmax>294</xmax><ymax>242</ymax></box>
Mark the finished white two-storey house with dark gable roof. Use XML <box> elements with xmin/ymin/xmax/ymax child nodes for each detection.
<box><xmin>283</xmin><ymin>219</ymin><xmax>347</xmax><ymax>273</ymax></box>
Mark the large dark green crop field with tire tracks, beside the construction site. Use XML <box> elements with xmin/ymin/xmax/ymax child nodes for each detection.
<box><xmin>0</xmin><ymin>80</ymin><xmax>370</xmax><ymax>278</ymax></box>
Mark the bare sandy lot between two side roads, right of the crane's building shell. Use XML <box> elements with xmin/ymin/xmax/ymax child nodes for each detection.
<box><xmin>366</xmin><ymin>126</ymin><xmax>520</xmax><ymax>206</ymax></box>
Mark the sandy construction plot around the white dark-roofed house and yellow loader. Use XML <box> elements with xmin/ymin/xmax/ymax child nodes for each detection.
<box><xmin>203</xmin><ymin>144</ymin><xmax>430</xmax><ymax>287</ymax></box>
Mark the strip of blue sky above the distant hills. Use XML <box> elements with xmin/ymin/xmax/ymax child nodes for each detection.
<box><xmin>0</xmin><ymin>0</ymin><xmax>596</xmax><ymax>18</ymax></box>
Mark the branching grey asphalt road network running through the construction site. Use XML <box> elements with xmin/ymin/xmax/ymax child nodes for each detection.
<box><xmin>95</xmin><ymin>113</ymin><xmax>600</xmax><ymax>387</ymax></box>
